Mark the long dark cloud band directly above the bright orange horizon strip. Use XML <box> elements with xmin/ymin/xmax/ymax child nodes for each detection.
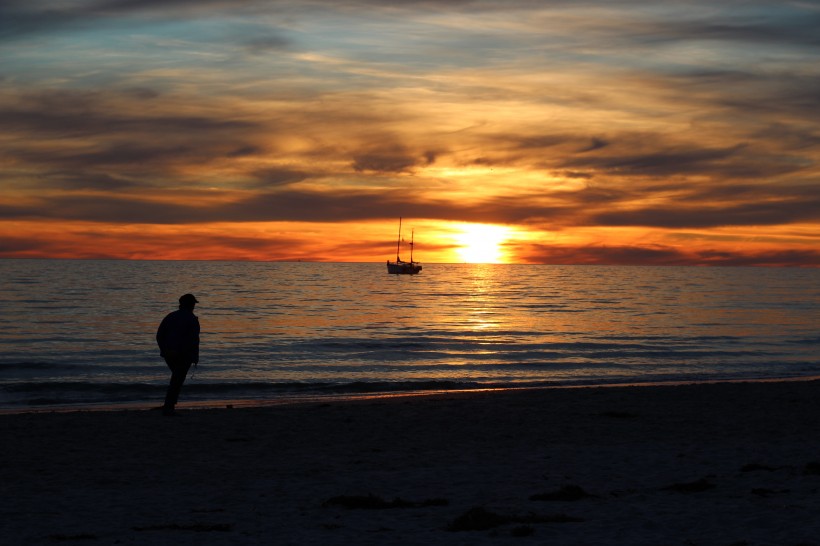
<box><xmin>0</xmin><ymin>170</ymin><xmax>820</xmax><ymax>229</ymax></box>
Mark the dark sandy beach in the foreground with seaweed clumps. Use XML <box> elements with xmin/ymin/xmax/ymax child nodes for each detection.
<box><xmin>0</xmin><ymin>381</ymin><xmax>820</xmax><ymax>546</ymax></box>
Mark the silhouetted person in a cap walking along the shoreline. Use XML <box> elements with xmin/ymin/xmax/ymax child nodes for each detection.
<box><xmin>157</xmin><ymin>294</ymin><xmax>199</xmax><ymax>415</ymax></box>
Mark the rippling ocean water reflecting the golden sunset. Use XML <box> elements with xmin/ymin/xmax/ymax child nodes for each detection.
<box><xmin>0</xmin><ymin>259</ymin><xmax>820</xmax><ymax>410</ymax></box>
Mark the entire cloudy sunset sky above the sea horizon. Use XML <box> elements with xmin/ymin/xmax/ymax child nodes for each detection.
<box><xmin>0</xmin><ymin>0</ymin><xmax>820</xmax><ymax>267</ymax></box>
